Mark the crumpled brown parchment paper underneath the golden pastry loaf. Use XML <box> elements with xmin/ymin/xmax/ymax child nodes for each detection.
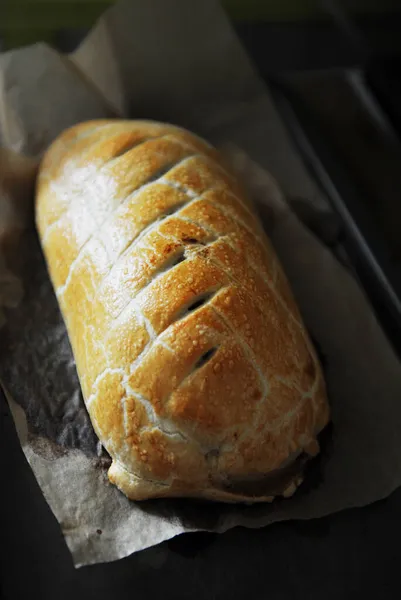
<box><xmin>0</xmin><ymin>0</ymin><xmax>401</xmax><ymax>566</ymax></box>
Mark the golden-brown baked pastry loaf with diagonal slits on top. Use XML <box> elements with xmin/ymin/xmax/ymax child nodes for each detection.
<box><xmin>36</xmin><ymin>121</ymin><xmax>329</xmax><ymax>502</ymax></box>
